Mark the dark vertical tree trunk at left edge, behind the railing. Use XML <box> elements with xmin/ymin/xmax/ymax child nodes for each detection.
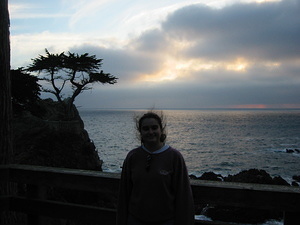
<box><xmin>0</xmin><ymin>0</ymin><xmax>16</xmax><ymax>224</ymax></box>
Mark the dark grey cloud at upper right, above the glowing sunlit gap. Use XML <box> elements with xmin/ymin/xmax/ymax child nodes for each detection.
<box><xmin>162</xmin><ymin>0</ymin><xmax>300</xmax><ymax>60</ymax></box>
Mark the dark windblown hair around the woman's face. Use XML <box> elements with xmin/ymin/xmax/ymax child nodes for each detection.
<box><xmin>135</xmin><ymin>111</ymin><xmax>167</xmax><ymax>143</ymax></box>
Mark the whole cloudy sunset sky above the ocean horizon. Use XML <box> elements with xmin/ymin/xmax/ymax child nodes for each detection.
<box><xmin>9</xmin><ymin>0</ymin><xmax>300</xmax><ymax>109</ymax></box>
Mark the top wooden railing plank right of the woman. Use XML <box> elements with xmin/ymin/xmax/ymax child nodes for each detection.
<box><xmin>191</xmin><ymin>180</ymin><xmax>300</xmax><ymax>212</ymax></box>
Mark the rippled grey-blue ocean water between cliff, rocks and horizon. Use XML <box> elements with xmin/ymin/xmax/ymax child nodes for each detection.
<box><xmin>79</xmin><ymin>109</ymin><xmax>300</xmax><ymax>182</ymax></box>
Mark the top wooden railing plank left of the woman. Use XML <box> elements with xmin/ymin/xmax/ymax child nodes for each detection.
<box><xmin>5</xmin><ymin>165</ymin><xmax>120</xmax><ymax>193</ymax></box>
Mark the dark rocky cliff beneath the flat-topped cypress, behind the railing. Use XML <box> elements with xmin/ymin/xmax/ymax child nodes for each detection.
<box><xmin>13</xmin><ymin>99</ymin><xmax>102</xmax><ymax>171</ymax></box>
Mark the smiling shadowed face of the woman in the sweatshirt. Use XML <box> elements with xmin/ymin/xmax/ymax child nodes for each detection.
<box><xmin>140</xmin><ymin>118</ymin><xmax>162</xmax><ymax>146</ymax></box>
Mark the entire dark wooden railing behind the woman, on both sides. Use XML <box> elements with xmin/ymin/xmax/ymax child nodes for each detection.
<box><xmin>0</xmin><ymin>165</ymin><xmax>300</xmax><ymax>225</ymax></box>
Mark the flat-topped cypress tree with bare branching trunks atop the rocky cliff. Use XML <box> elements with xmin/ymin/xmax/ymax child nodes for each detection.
<box><xmin>27</xmin><ymin>49</ymin><xmax>118</xmax><ymax>111</ymax></box>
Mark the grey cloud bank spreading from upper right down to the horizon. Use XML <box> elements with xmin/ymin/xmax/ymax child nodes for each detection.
<box><xmin>73</xmin><ymin>0</ymin><xmax>300</xmax><ymax>108</ymax></box>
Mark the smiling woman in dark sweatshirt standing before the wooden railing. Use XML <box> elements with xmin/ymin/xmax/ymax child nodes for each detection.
<box><xmin>117</xmin><ymin>112</ymin><xmax>194</xmax><ymax>225</ymax></box>
